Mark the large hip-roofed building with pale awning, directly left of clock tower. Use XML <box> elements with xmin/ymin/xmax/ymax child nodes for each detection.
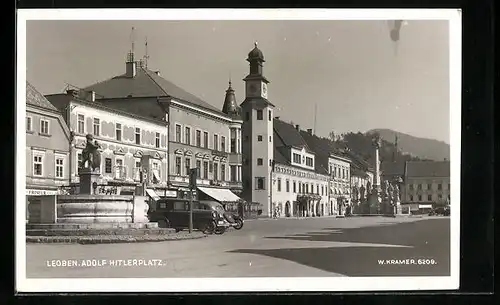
<box><xmin>67</xmin><ymin>52</ymin><xmax>242</xmax><ymax>200</ymax></box>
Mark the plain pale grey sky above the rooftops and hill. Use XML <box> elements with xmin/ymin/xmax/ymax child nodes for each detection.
<box><xmin>26</xmin><ymin>20</ymin><xmax>450</xmax><ymax>143</ymax></box>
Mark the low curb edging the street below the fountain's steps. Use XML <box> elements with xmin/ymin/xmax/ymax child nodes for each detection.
<box><xmin>26</xmin><ymin>233</ymin><xmax>207</xmax><ymax>245</ymax></box>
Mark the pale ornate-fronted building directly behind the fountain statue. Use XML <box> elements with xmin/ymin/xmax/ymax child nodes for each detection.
<box><xmin>47</xmin><ymin>90</ymin><xmax>168</xmax><ymax>194</ymax></box>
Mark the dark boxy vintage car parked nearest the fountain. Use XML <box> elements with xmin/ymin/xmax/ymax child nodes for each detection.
<box><xmin>148</xmin><ymin>199</ymin><xmax>227</xmax><ymax>234</ymax></box>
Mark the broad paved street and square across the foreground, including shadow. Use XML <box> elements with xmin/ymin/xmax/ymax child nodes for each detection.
<box><xmin>26</xmin><ymin>216</ymin><xmax>450</xmax><ymax>278</ymax></box>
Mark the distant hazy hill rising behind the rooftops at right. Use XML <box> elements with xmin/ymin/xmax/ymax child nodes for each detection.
<box><xmin>366</xmin><ymin>129</ymin><xmax>450</xmax><ymax>161</ymax></box>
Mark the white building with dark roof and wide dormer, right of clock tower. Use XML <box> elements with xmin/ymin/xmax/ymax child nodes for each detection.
<box><xmin>272</xmin><ymin>118</ymin><xmax>329</xmax><ymax>217</ymax></box>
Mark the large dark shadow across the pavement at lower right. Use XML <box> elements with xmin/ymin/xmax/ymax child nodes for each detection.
<box><xmin>230</xmin><ymin>219</ymin><xmax>450</xmax><ymax>277</ymax></box>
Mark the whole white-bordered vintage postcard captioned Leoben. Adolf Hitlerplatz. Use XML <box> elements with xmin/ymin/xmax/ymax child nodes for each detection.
<box><xmin>16</xmin><ymin>9</ymin><xmax>461</xmax><ymax>292</ymax></box>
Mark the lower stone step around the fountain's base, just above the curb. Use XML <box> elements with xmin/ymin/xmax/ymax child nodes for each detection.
<box><xmin>26</xmin><ymin>228</ymin><xmax>175</xmax><ymax>237</ymax></box>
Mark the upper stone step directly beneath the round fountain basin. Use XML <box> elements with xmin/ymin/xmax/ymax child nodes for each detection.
<box><xmin>26</xmin><ymin>222</ymin><xmax>158</xmax><ymax>230</ymax></box>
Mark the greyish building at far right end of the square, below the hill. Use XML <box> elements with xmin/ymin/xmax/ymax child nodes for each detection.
<box><xmin>403</xmin><ymin>161</ymin><xmax>451</xmax><ymax>212</ymax></box>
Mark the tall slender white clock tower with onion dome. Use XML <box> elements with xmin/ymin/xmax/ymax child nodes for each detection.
<box><xmin>240</xmin><ymin>43</ymin><xmax>274</xmax><ymax>216</ymax></box>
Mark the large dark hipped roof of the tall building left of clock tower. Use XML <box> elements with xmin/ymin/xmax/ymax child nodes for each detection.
<box><xmin>83</xmin><ymin>65</ymin><xmax>227</xmax><ymax>114</ymax></box>
